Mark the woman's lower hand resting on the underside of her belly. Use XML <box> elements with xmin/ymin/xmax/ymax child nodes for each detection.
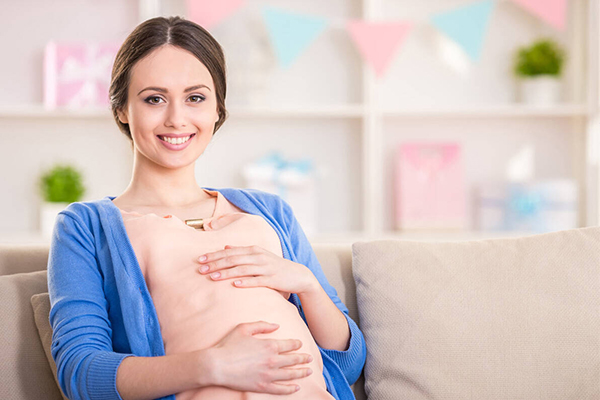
<box><xmin>207</xmin><ymin>321</ymin><xmax>312</xmax><ymax>394</ymax></box>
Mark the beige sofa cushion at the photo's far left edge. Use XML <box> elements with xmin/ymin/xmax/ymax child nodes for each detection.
<box><xmin>0</xmin><ymin>271</ymin><xmax>62</xmax><ymax>400</ymax></box>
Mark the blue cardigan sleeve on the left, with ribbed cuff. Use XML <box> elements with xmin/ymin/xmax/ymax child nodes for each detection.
<box><xmin>48</xmin><ymin>211</ymin><xmax>133</xmax><ymax>400</ymax></box>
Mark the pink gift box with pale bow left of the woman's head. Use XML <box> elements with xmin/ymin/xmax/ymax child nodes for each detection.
<box><xmin>44</xmin><ymin>42</ymin><xmax>120</xmax><ymax>109</ymax></box>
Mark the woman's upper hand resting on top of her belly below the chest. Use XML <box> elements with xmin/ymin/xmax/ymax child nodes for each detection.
<box><xmin>198</xmin><ymin>245</ymin><xmax>319</xmax><ymax>295</ymax></box>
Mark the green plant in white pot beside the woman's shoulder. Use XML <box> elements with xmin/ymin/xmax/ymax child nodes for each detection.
<box><xmin>39</xmin><ymin>164</ymin><xmax>85</xmax><ymax>238</ymax></box>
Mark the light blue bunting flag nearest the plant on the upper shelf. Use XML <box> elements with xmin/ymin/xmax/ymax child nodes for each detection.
<box><xmin>432</xmin><ymin>0</ymin><xmax>494</xmax><ymax>61</ymax></box>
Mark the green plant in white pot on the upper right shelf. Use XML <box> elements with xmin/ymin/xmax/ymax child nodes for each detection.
<box><xmin>514</xmin><ymin>39</ymin><xmax>565</xmax><ymax>105</ymax></box>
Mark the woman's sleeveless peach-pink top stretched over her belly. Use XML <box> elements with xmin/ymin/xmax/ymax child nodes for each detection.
<box><xmin>121</xmin><ymin>189</ymin><xmax>334</xmax><ymax>400</ymax></box>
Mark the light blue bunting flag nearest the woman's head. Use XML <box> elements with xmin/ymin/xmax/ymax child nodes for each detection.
<box><xmin>263</xmin><ymin>6</ymin><xmax>327</xmax><ymax>67</ymax></box>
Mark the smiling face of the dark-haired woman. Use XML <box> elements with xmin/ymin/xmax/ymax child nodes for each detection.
<box><xmin>119</xmin><ymin>45</ymin><xmax>219</xmax><ymax>168</ymax></box>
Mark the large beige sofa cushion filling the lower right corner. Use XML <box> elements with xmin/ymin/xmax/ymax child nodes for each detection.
<box><xmin>352</xmin><ymin>227</ymin><xmax>600</xmax><ymax>400</ymax></box>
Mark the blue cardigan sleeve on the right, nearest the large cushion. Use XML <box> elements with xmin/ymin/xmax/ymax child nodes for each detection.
<box><xmin>281</xmin><ymin>199</ymin><xmax>367</xmax><ymax>385</ymax></box>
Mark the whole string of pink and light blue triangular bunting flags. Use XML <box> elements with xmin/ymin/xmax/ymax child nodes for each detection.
<box><xmin>186</xmin><ymin>0</ymin><xmax>569</xmax><ymax>78</ymax></box>
